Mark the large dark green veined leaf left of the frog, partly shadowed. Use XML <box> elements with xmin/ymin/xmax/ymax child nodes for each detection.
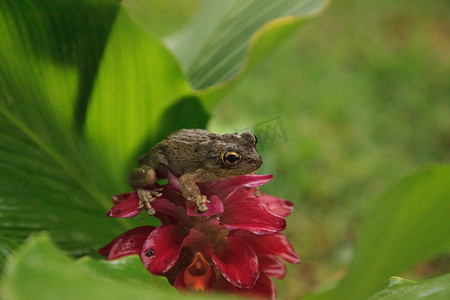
<box><xmin>0</xmin><ymin>0</ymin><xmax>142</xmax><ymax>255</ymax></box>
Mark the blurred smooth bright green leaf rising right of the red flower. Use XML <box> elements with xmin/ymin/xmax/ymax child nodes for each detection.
<box><xmin>316</xmin><ymin>165</ymin><xmax>450</xmax><ymax>299</ymax></box>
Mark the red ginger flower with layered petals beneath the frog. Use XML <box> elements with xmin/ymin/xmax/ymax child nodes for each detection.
<box><xmin>99</xmin><ymin>173</ymin><xmax>299</xmax><ymax>299</ymax></box>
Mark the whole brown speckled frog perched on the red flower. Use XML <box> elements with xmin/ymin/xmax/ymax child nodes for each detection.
<box><xmin>129</xmin><ymin>129</ymin><xmax>262</xmax><ymax>215</ymax></box>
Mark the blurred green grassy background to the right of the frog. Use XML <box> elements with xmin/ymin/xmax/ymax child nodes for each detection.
<box><xmin>208</xmin><ymin>0</ymin><xmax>450</xmax><ymax>297</ymax></box>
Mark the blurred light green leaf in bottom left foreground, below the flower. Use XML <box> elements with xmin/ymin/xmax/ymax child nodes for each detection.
<box><xmin>0</xmin><ymin>234</ymin><xmax>179</xmax><ymax>300</ymax></box>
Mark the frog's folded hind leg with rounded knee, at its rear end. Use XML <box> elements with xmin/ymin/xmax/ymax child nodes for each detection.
<box><xmin>128</xmin><ymin>165</ymin><xmax>162</xmax><ymax>215</ymax></box>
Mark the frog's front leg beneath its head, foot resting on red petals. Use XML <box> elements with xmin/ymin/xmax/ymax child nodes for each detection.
<box><xmin>179</xmin><ymin>171</ymin><xmax>213</xmax><ymax>213</ymax></box>
